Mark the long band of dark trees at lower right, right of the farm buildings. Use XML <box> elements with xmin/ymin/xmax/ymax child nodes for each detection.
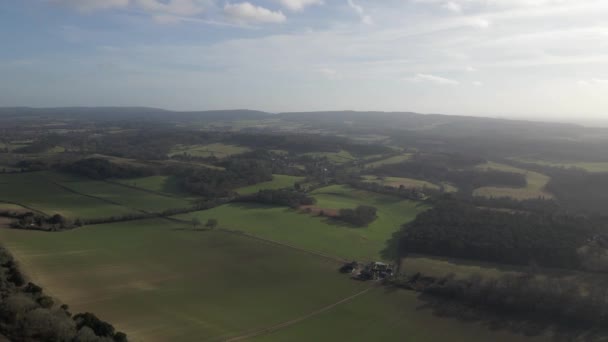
<box><xmin>388</xmin><ymin>273</ymin><xmax>608</xmax><ymax>328</ymax></box>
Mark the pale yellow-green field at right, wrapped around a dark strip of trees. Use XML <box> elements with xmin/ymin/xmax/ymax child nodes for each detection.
<box><xmin>474</xmin><ymin>162</ymin><xmax>553</xmax><ymax>199</ymax></box>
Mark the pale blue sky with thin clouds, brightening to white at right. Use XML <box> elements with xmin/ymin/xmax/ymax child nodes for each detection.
<box><xmin>0</xmin><ymin>0</ymin><xmax>608</xmax><ymax>122</ymax></box>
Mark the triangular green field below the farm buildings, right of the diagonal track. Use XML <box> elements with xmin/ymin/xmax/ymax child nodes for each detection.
<box><xmin>252</xmin><ymin>288</ymin><xmax>551</xmax><ymax>342</ymax></box>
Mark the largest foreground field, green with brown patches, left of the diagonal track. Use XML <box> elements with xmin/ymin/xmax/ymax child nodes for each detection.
<box><xmin>0</xmin><ymin>220</ymin><xmax>368</xmax><ymax>341</ymax></box>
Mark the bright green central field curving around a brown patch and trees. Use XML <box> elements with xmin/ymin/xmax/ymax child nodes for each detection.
<box><xmin>179</xmin><ymin>186</ymin><xmax>426</xmax><ymax>261</ymax></box>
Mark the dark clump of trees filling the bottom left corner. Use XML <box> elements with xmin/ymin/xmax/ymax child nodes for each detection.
<box><xmin>0</xmin><ymin>247</ymin><xmax>127</xmax><ymax>342</ymax></box>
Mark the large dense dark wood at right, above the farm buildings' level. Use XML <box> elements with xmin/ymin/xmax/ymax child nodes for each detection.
<box><xmin>397</xmin><ymin>200</ymin><xmax>596</xmax><ymax>269</ymax></box>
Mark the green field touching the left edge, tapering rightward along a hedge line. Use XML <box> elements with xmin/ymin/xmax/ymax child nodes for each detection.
<box><xmin>0</xmin><ymin>172</ymin><xmax>136</xmax><ymax>219</ymax></box>
